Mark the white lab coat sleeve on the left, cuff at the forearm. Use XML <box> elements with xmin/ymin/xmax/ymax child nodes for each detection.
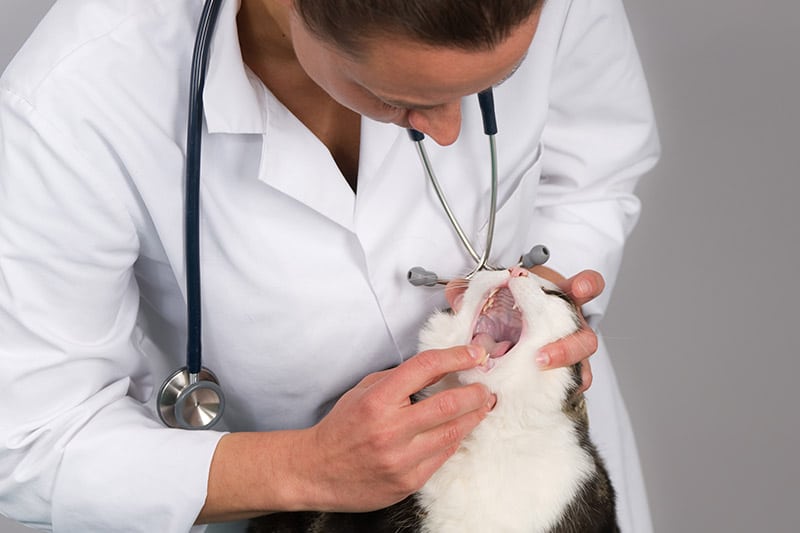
<box><xmin>0</xmin><ymin>89</ymin><xmax>221</xmax><ymax>533</ymax></box>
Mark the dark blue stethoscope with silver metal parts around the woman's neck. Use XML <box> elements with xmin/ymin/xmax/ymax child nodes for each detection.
<box><xmin>157</xmin><ymin>0</ymin><xmax>550</xmax><ymax>429</ymax></box>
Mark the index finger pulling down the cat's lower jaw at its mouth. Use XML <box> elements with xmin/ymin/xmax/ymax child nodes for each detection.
<box><xmin>379</xmin><ymin>345</ymin><xmax>488</xmax><ymax>403</ymax></box>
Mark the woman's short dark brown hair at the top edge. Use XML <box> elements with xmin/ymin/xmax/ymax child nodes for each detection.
<box><xmin>294</xmin><ymin>0</ymin><xmax>544</xmax><ymax>54</ymax></box>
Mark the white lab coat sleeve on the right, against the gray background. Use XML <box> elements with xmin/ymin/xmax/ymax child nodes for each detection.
<box><xmin>533</xmin><ymin>0</ymin><xmax>659</xmax><ymax>320</ymax></box>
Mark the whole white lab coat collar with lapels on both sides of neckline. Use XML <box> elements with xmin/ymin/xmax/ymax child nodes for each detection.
<box><xmin>198</xmin><ymin>0</ymin><xmax>404</xmax><ymax>231</ymax></box>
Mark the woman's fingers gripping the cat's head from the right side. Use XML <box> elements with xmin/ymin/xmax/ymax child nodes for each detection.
<box><xmin>531</xmin><ymin>266</ymin><xmax>605</xmax><ymax>392</ymax></box>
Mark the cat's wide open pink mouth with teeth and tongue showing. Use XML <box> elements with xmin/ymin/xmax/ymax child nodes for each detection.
<box><xmin>472</xmin><ymin>287</ymin><xmax>522</xmax><ymax>370</ymax></box>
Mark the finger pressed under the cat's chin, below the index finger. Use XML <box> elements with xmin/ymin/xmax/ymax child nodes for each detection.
<box><xmin>409</xmin><ymin>383</ymin><xmax>497</xmax><ymax>430</ymax></box>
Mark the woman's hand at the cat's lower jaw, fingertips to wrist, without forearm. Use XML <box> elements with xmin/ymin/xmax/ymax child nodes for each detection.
<box><xmin>297</xmin><ymin>346</ymin><xmax>496</xmax><ymax>512</ymax></box>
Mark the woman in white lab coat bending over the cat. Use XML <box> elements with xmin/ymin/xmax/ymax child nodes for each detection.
<box><xmin>0</xmin><ymin>0</ymin><xmax>658</xmax><ymax>533</ymax></box>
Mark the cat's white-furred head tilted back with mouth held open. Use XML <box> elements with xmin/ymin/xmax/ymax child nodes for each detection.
<box><xmin>420</xmin><ymin>268</ymin><xmax>581</xmax><ymax>391</ymax></box>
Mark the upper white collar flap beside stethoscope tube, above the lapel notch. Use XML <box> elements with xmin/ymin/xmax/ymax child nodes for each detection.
<box><xmin>203</xmin><ymin>0</ymin><xmax>266</xmax><ymax>134</ymax></box>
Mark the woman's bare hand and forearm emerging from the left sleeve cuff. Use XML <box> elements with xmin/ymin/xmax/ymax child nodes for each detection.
<box><xmin>197</xmin><ymin>346</ymin><xmax>496</xmax><ymax>524</ymax></box>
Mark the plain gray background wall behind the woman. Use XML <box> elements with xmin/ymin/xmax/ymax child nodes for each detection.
<box><xmin>0</xmin><ymin>0</ymin><xmax>800</xmax><ymax>533</ymax></box>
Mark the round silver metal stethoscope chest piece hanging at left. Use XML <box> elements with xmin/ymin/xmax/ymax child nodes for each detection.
<box><xmin>158</xmin><ymin>367</ymin><xmax>225</xmax><ymax>429</ymax></box>
